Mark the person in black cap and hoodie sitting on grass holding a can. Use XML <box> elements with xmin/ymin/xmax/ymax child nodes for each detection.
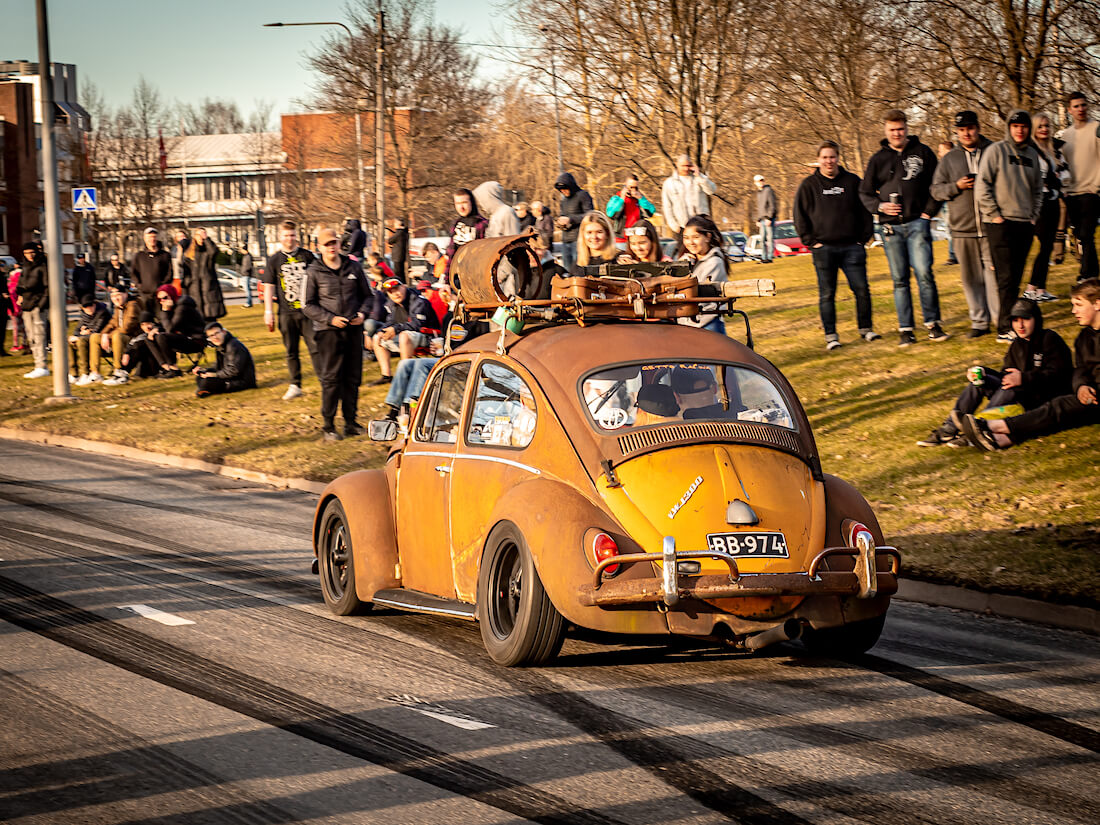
<box><xmin>916</xmin><ymin>298</ymin><xmax>1074</xmax><ymax>447</ymax></box>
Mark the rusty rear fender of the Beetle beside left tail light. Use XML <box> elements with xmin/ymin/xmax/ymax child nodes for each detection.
<box><xmin>490</xmin><ymin>479</ymin><xmax>669</xmax><ymax>634</ymax></box>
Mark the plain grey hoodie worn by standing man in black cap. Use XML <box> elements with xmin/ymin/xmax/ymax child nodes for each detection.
<box><xmin>975</xmin><ymin>109</ymin><xmax>1043</xmax><ymax>223</ymax></box>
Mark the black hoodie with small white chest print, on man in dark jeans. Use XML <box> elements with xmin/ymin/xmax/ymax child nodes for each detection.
<box><xmin>794</xmin><ymin>166</ymin><xmax>875</xmax><ymax>248</ymax></box>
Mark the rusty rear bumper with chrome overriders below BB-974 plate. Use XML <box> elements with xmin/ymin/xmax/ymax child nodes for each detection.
<box><xmin>578</xmin><ymin>537</ymin><xmax>901</xmax><ymax>607</ymax></box>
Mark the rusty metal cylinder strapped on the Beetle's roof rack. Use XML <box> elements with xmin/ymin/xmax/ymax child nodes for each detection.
<box><xmin>451</xmin><ymin>231</ymin><xmax>550</xmax><ymax>304</ymax></box>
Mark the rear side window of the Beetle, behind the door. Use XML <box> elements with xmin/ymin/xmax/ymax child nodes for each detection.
<box><xmin>466</xmin><ymin>362</ymin><xmax>538</xmax><ymax>449</ymax></box>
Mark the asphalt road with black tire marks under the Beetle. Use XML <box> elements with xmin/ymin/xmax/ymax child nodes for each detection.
<box><xmin>0</xmin><ymin>442</ymin><xmax>1100</xmax><ymax>825</ymax></box>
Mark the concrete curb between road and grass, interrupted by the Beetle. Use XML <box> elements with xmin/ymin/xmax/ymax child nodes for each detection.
<box><xmin>0</xmin><ymin>427</ymin><xmax>1100</xmax><ymax>636</ymax></box>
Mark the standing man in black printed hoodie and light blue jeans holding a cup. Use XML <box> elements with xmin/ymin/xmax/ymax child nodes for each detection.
<box><xmin>859</xmin><ymin>109</ymin><xmax>950</xmax><ymax>347</ymax></box>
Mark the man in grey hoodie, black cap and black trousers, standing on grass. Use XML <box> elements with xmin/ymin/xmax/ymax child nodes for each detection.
<box><xmin>975</xmin><ymin>109</ymin><xmax>1043</xmax><ymax>342</ymax></box>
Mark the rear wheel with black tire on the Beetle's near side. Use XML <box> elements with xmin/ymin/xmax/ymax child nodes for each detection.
<box><xmin>477</xmin><ymin>521</ymin><xmax>565</xmax><ymax>668</ymax></box>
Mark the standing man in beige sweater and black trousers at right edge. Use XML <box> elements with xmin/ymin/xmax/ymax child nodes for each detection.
<box><xmin>1062</xmin><ymin>91</ymin><xmax>1100</xmax><ymax>281</ymax></box>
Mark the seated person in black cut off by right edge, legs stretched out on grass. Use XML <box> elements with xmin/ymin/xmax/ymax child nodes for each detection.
<box><xmin>964</xmin><ymin>278</ymin><xmax>1100</xmax><ymax>450</ymax></box>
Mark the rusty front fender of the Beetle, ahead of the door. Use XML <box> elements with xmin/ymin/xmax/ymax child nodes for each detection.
<box><xmin>314</xmin><ymin>470</ymin><xmax>400</xmax><ymax>602</ymax></box>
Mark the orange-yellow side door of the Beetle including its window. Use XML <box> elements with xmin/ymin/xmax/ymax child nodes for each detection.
<box><xmin>397</xmin><ymin>360</ymin><xmax>471</xmax><ymax>598</ymax></box>
